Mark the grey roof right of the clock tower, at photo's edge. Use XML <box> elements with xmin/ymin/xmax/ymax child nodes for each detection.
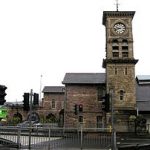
<box><xmin>136</xmin><ymin>75</ymin><xmax>150</xmax><ymax>111</ymax></box>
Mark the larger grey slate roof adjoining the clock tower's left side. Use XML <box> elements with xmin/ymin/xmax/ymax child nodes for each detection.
<box><xmin>62</xmin><ymin>73</ymin><xmax>105</xmax><ymax>84</ymax></box>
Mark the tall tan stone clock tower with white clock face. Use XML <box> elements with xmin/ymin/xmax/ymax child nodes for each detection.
<box><xmin>103</xmin><ymin>10</ymin><xmax>138</xmax><ymax>130</ymax></box>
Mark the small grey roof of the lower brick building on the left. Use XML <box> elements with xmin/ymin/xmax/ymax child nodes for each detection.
<box><xmin>43</xmin><ymin>86</ymin><xmax>65</xmax><ymax>93</ymax></box>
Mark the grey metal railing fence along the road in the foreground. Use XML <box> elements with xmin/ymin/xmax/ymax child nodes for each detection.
<box><xmin>0</xmin><ymin>126</ymin><xmax>112</xmax><ymax>150</ymax></box>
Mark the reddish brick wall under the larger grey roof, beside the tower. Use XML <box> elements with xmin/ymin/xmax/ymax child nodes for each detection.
<box><xmin>65</xmin><ymin>85</ymin><xmax>102</xmax><ymax>127</ymax></box>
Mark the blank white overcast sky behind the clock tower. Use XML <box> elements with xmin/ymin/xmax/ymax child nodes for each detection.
<box><xmin>0</xmin><ymin>0</ymin><xmax>150</xmax><ymax>102</ymax></box>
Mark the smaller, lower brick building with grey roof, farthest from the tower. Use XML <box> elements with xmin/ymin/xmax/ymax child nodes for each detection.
<box><xmin>38</xmin><ymin>86</ymin><xmax>65</xmax><ymax>126</ymax></box>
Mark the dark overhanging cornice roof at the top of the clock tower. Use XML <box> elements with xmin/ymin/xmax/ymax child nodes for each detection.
<box><xmin>103</xmin><ymin>11</ymin><xmax>135</xmax><ymax>25</ymax></box>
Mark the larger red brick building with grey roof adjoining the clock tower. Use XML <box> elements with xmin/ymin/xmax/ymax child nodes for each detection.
<box><xmin>62</xmin><ymin>73</ymin><xmax>106</xmax><ymax>128</ymax></box>
